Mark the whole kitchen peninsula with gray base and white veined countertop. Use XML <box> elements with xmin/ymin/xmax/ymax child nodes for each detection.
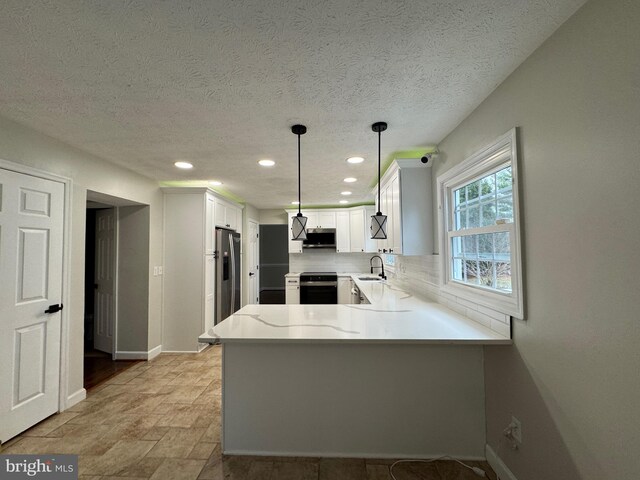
<box><xmin>200</xmin><ymin>276</ymin><xmax>511</xmax><ymax>458</ymax></box>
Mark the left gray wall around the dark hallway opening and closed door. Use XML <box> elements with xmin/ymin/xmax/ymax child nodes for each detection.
<box><xmin>0</xmin><ymin>117</ymin><xmax>162</xmax><ymax>402</ymax></box>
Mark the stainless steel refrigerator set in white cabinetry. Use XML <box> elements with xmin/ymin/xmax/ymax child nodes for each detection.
<box><xmin>215</xmin><ymin>228</ymin><xmax>240</xmax><ymax>325</ymax></box>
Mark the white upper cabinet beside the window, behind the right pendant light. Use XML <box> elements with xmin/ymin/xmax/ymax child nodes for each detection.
<box><xmin>375</xmin><ymin>159</ymin><xmax>433</xmax><ymax>255</ymax></box>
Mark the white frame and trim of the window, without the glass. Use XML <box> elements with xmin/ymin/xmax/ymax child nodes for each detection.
<box><xmin>437</xmin><ymin>128</ymin><xmax>524</xmax><ymax>319</ymax></box>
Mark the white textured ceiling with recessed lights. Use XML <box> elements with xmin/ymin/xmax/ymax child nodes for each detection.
<box><xmin>0</xmin><ymin>0</ymin><xmax>584</xmax><ymax>208</ymax></box>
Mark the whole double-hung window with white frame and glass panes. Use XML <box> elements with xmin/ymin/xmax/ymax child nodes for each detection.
<box><xmin>438</xmin><ymin>129</ymin><xmax>523</xmax><ymax>318</ymax></box>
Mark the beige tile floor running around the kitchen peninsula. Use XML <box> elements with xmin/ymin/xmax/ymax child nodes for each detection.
<box><xmin>0</xmin><ymin>346</ymin><xmax>495</xmax><ymax>480</ymax></box>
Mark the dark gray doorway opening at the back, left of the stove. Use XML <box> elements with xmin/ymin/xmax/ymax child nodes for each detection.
<box><xmin>259</xmin><ymin>225</ymin><xmax>289</xmax><ymax>304</ymax></box>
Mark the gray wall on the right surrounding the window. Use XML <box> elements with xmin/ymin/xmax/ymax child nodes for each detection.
<box><xmin>434</xmin><ymin>0</ymin><xmax>640</xmax><ymax>480</ymax></box>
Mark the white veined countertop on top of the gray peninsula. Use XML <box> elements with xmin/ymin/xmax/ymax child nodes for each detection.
<box><xmin>199</xmin><ymin>274</ymin><xmax>511</xmax><ymax>345</ymax></box>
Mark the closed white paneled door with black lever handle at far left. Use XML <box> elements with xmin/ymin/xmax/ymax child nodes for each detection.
<box><xmin>0</xmin><ymin>169</ymin><xmax>64</xmax><ymax>442</ymax></box>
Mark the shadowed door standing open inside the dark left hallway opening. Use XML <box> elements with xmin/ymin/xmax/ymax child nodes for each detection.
<box><xmin>93</xmin><ymin>208</ymin><xmax>116</xmax><ymax>354</ymax></box>
